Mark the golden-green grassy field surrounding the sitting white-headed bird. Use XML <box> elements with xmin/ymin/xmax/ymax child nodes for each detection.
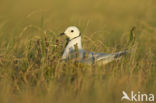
<box><xmin>0</xmin><ymin>0</ymin><xmax>156</xmax><ymax>103</ymax></box>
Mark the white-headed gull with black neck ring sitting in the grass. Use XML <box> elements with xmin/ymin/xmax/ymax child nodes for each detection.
<box><xmin>60</xmin><ymin>26</ymin><xmax>129</xmax><ymax>64</ymax></box>
